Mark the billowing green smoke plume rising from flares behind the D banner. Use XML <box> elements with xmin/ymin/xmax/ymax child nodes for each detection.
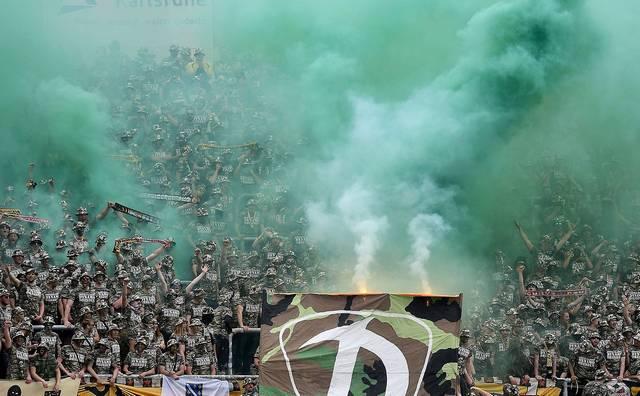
<box><xmin>209</xmin><ymin>1</ymin><xmax>599</xmax><ymax>289</ymax></box>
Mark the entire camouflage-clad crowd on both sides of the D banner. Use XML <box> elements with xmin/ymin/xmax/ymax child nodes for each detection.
<box><xmin>0</xmin><ymin>42</ymin><xmax>640</xmax><ymax>395</ymax></box>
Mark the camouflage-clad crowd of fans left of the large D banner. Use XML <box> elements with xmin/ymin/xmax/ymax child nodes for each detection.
<box><xmin>0</xmin><ymin>45</ymin><xmax>326</xmax><ymax>395</ymax></box>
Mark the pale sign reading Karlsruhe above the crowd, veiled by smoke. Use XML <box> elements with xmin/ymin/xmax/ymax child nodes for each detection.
<box><xmin>43</xmin><ymin>0</ymin><xmax>215</xmax><ymax>60</ymax></box>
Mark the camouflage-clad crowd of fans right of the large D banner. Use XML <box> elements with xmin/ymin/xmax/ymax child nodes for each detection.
<box><xmin>458</xmin><ymin>169</ymin><xmax>640</xmax><ymax>395</ymax></box>
